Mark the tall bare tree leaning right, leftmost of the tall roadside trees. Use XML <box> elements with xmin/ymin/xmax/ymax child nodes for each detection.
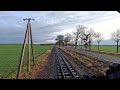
<box><xmin>74</xmin><ymin>25</ymin><xmax>87</xmax><ymax>48</ymax></box>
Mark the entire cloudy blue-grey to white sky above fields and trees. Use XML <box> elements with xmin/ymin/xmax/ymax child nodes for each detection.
<box><xmin>0</xmin><ymin>11</ymin><xmax>120</xmax><ymax>43</ymax></box>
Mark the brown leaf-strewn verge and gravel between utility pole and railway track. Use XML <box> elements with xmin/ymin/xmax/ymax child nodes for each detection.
<box><xmin>21</xmin><ymin>50</ymin><xmax>57</xmax><ymax>79</ymax></box>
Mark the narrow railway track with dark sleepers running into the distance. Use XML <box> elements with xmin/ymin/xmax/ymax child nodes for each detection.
<box><xmin>54</xmin><ymin>46</ymin><xmax>79</xmax><ymax>79</ymax></box>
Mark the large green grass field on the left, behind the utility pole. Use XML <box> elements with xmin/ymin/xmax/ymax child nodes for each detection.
<box><xmin>0</xmin><ymin>44</ymin><xmax>51</xmax><ymax>78</ymax></box>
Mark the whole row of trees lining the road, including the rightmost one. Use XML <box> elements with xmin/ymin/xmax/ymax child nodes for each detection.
<box><xmin>55</xmin><ymin>25</ymin><xmax>120</xmax><ymax>53</ymax></box>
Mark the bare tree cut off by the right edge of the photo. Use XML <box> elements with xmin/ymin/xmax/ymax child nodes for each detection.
<box><xmin>111</xmin><ymin>29</ymin><xmax>120</xmax><ymax>53</ymax></box>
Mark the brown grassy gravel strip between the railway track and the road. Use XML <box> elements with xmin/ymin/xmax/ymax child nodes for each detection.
<box><xmin>58</xmin><ymin>47</ymin><xmax>113</xmax><ymax>78</ymax></box>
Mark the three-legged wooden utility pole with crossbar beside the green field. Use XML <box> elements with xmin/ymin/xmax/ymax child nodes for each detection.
<box><xmin>17</xmin><ymin>18</ymin><xmax>35</xmax><ymax>79</ymax></box>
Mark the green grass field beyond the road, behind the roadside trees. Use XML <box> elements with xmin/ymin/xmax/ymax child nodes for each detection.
<box><xmin>78</xmin><ymin>45</ymin><xmax>120</xmax><ymax>53</ymax></box>
